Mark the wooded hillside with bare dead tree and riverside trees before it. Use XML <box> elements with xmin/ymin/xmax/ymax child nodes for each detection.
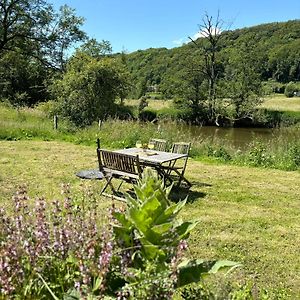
<box><xmin>119</xmin><ymin>19</ymin><xmax>300</xmax><ymax>126</ymax></box>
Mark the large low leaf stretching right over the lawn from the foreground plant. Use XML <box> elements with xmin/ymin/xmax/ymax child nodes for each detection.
<box><xmin>178</xmin><ymin>259</ymin><xmax>241</xmax><ymax>287</ymax></box>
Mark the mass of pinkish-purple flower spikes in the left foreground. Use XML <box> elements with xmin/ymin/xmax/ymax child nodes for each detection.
<box><xmin>0</xmin><ymin>186</ymin><xmax>112</xmax><ymax>299</ymax></box>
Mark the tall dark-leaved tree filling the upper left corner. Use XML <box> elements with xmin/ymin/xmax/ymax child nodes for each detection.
<box><xmin>0</xmin><ymin>0</ymin><xmax>86</xmax><ymax>106</ymax></box>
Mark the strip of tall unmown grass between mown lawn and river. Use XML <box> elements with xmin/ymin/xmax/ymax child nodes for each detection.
<box><xmin>0</xmin><ymin>105</ymin><xmax>300</xmax><ymax>170</ymax></box>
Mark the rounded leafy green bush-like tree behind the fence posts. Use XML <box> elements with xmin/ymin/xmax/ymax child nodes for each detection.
<box><xmin>51</xmin><ymin>52</ymin><xmax>128</xmax><ymax>126</ymax></box>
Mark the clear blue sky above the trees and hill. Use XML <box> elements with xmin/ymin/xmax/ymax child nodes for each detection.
<box><xmin>49</xmin><ymin>0</ymin><xmax>300</xmax><ymax>52</ymax></box>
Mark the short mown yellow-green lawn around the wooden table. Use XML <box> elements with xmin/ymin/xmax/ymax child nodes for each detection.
<box><xmin>0</xmin><ymin>141</ymin><xmax>300</xmax><ymax>299</ymax></box>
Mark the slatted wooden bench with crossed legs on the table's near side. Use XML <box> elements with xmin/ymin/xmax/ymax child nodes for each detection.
<box><xmin>97</xmin><ymin>148</ymin><xmax>142</xmax><ymax>201</ymax></box>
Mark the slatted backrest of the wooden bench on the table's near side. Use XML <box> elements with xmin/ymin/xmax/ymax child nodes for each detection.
<box><xmin>97</xmin><ymin>148</ymin><xmax>141</xmax><ymax>177</ymax></box>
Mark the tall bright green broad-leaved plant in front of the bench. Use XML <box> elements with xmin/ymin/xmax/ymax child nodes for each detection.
<box><xmin>113</xmin><ymin>168</ymin><xmax>238</xmax><ymax>299</ymax></box>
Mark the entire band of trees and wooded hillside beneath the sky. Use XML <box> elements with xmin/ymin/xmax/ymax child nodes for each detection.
<box><xmin>0</xmin><ymin>0</ymin><xmax>300</xmax><ymax>126</ymax></box>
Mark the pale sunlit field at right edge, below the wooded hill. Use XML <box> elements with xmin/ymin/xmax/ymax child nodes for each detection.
<box><xmin>261</xmin><ymin>94</ymin><xmax>300</xmax><ymax>111</ymax></box>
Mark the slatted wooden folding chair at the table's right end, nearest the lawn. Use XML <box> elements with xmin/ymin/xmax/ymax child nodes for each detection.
<box><xmin>168</xmin><ymin>142</ymin><xmax>192</xmax><ymax>187</ymax></box>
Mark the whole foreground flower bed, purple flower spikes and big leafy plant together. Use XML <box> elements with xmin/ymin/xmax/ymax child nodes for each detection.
<box><xmin>0</xmin><ymin>169</ymin><xmax>237</xmax><ymax>300</ymax></box>
